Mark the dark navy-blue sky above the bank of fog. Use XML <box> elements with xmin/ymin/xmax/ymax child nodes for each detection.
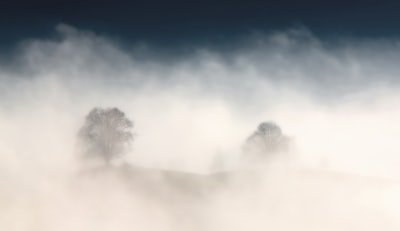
<box><xmin>0</xmin><ymin>0</ymin><xmax>400</xmax><ymax>46</ymax></box>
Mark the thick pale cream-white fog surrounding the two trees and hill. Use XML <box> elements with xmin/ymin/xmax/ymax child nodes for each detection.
<box><xmin>0</xmin><ymin>24</ymin><xmax>400</xmax><ymax>231</ymax></box>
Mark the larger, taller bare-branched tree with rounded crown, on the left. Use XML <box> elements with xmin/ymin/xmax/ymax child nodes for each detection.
<box><xmin>79</xmin><ymin>107</ymin><xmax>133</xmax><ymax>164</ymax></box>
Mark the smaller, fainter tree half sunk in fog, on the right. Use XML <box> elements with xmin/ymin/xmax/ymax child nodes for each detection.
<box><xmin>243</xmin><ymin>121</ymin><xmax>289</xmax><ymax>161</ymax></box>
